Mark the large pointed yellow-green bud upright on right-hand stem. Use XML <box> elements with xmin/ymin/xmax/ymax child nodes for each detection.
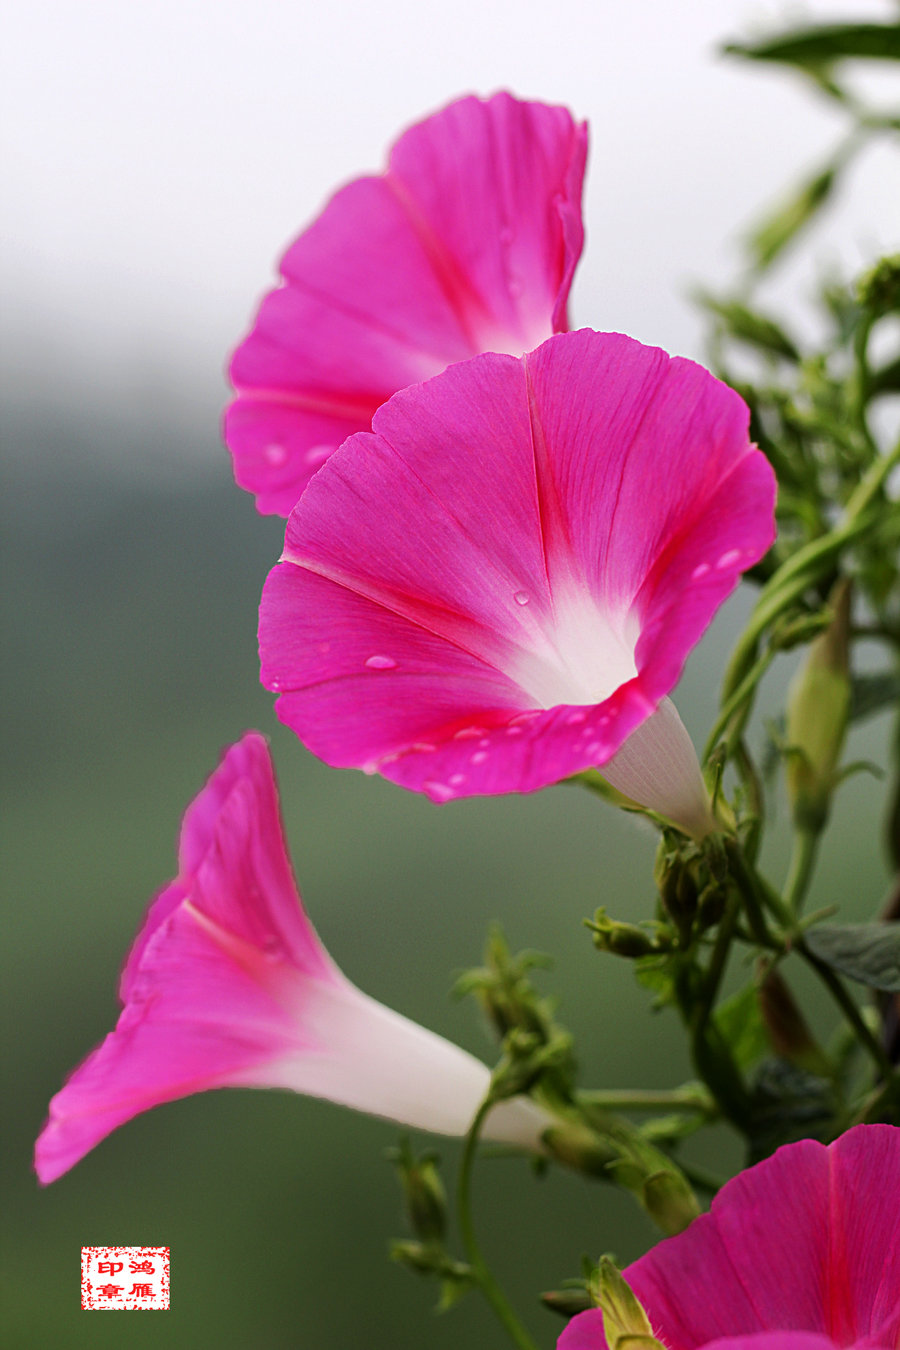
<box><xmin>785</xmin><ymin>579</ymin><xmax>850</xmax><ymax>830</ymax></box>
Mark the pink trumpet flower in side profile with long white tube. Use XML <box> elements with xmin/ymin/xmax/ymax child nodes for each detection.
<box><xmin>35</xmin><ymin>732</ymin><xmax>551</xmax><ymax>1183</ymax></box>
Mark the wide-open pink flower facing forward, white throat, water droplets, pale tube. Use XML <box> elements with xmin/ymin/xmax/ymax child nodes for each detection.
<box><xmin>259</xmin><ymin>329</ymin><xmax>775</xmax><ymax>834</ymax></box>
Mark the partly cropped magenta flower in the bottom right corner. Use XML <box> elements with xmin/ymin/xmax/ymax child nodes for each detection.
<box><xmin>559</xmin><ymin>1125</ymin><xmax>900</xmax><ymax>1350</ymax></box>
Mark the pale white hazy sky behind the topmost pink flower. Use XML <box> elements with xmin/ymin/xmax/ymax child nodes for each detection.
<box><xmin>0</xmin><ymin>0</ymin><xmax>900</xmax><ymax>464</ymax></box>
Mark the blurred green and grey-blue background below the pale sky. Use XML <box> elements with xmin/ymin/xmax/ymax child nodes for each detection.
<box><xmin>3</xmin><ymin>383</ymin><xmax>887</xmax><ymax>1350</ymax></box>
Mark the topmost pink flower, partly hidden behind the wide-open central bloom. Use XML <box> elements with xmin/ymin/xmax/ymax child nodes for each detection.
<box><xmin>225</xmin><ymin>93</ymin><xmax>587</xmax><ymax>516</ymax></box>
